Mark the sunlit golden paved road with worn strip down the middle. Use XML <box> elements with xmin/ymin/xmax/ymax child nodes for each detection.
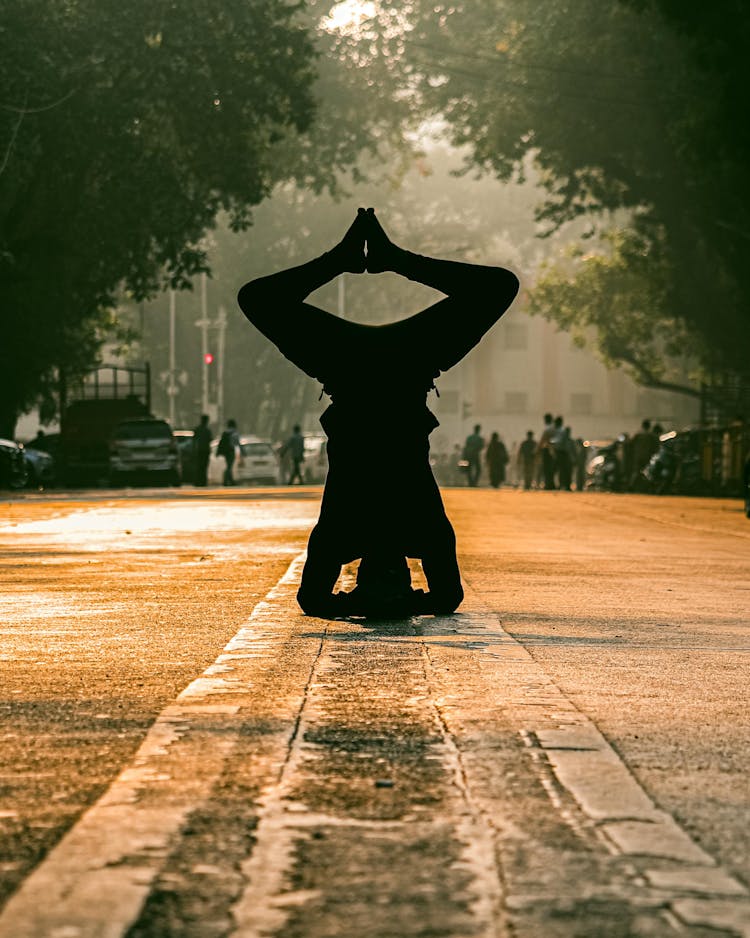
<box><xmin>0</xmin><ymin>488</ymin><xmax>750</xmax><ymax>938</ymax></box>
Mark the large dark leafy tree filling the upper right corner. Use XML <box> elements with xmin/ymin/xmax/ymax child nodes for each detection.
<box><xmin>405</xmin><ymin>0</ymin><xmax>750</xmax><ymax>380</ymax></box>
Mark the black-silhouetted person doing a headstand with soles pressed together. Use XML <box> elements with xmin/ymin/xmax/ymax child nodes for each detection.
<box><xmin>238</xmin><ymin>209</ymin><xmax>518</xmax><ymax>617</ymax></box>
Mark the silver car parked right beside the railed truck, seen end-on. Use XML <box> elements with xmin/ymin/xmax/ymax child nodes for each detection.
<box><xmin>109</xmin><ymin>417</ymin><xmax>180</xmax><ymax>485</ymax></box>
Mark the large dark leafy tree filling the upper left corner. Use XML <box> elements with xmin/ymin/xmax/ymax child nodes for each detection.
<box><xmin>0</xmin><ymin>0</ymin><xmax>315</xmax><ymax>436</ymax></box>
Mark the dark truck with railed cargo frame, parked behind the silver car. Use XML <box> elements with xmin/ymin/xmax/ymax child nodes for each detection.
<box><xmin>57</xmin><ymin>364</ymin><xmax>153</xmax><ymax>486</ymax></box>
